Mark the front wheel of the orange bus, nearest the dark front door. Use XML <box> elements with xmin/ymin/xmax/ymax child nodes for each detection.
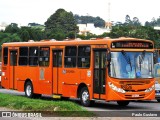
<box><xmin>80</xmin><ymin>87</ymin><xmax>91</xmax><ymax>107</ymax></box>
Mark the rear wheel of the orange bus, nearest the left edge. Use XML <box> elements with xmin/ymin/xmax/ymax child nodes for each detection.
<box><xmin>25</xmin><ymin>82</ymin><xmax>34</xmax><ymax>98</ymax></box>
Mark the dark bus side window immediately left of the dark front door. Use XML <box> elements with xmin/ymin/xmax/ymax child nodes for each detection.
<box><xmin>78</xmin><ymin>46</ymin><xmax>91</xmax><ymax>68</ymax></box>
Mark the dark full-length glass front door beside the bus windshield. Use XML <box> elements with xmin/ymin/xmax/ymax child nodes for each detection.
<box><xmin>93</xmin><ymin>50</ymin><xmax>106</xmax><ymax>99</ymax></box>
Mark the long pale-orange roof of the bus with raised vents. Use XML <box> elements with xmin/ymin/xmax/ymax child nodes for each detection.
<box><xmin>2</xmin><ymin>37</ymin><xmax>154</xmax><ymax>47</ymax></box>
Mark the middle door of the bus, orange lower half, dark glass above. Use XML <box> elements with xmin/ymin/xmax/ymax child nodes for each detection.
<box><xmin>52</xmin><ymin>50</ymin><xmax>63</xmax><ymax>94</ymax></box>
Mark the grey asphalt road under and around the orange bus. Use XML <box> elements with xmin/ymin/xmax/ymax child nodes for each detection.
<box><xmin>0</xmin><ymin>88</ymin><xmax>160</xmax><ymax>120</ymax></box>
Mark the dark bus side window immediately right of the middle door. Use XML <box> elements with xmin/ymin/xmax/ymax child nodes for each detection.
<box><xmin>64</xmin><ymin>46</ymin><xmax>77</xmax><ymax>67</ymax></box>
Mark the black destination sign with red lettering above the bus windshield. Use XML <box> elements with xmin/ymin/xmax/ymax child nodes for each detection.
<box><xmin>111</xmin><ymin>41</ymin><xmax>153</xmax><ymax>49</ymax></box>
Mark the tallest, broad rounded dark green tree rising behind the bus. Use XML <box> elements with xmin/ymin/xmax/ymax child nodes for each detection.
<box><xmin>45</xmin><ymin>9</ymin><xmax>78</xmax><ymax>38</ymax></box>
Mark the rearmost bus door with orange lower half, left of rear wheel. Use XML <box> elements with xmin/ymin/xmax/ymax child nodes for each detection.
<box><xmin>9</xmin><ymin>50</ymin><xmax>18</xmax><ymax>89</ymax></box>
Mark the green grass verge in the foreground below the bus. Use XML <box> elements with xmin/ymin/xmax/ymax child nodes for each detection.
<box><xmin>0</xmin><ymin>93</ymin><xmax>95</xmax><ymax>117</ymax></box>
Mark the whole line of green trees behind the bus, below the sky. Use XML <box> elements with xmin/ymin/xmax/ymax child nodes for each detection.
<box><xmin>0</xmin><ymin>9</ymin><xmax>160</xmax><ymax>47</ymax></box>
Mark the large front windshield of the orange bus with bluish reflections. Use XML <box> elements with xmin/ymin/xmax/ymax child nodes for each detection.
<box><xmin>110</xmin><ymin>51</ymin><xmax>154</xmax><ymax>79</ymax></box>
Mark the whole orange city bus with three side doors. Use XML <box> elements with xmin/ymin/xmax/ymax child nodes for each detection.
<box><xmin>1</xmin><ymin>37</ymin><xmax>155</xmax><ymax>106</ymax></box>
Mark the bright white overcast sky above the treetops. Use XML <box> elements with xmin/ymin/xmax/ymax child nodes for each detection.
<box><xmin>0</xmin><ymin>0</ymin><xmax>160</xmax><ymax>25</ymax></box>
